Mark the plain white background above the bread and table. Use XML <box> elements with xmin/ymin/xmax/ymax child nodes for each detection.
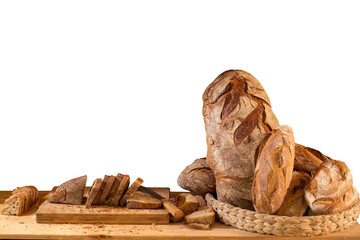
<box><xmin>0</xmin><ymin>0</ymin><xmax>360</xmax><ymax>197</ymax></box>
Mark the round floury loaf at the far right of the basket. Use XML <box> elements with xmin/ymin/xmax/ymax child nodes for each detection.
<box><xmin>305</xmin><ymin>160</ymin><xmax>359</xmax><ymax>215</ymax></box>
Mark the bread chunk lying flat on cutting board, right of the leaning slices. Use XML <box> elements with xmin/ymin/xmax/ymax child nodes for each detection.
<box><xmin>126</xmin><ymin>191</ymin><xmax>162</xmax><ymax>209</ymax></box>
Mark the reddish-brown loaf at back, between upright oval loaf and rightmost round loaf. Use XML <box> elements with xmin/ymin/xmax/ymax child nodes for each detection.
<box><xmin>294</xmin><ymin>144</ymin><xmax>330</xmax><ymax>174</ymax></box>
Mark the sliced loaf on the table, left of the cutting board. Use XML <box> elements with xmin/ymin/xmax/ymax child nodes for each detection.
<box><xmin>1</xmin><ymin>186</ymin><xmax>39</xmax><ymax>216</ymax></box>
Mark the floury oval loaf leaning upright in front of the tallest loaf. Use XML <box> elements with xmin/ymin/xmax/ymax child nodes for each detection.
<box><xmin>252</xmin><ymin>125</ymin><xmax>295</xmax><ymax>214</ymax></box>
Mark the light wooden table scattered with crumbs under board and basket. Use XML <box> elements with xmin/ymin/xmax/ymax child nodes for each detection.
<box><xmin>0</xmin><ymin>191</ymin><xmax>360</xmax><ymax>240</ymax></box>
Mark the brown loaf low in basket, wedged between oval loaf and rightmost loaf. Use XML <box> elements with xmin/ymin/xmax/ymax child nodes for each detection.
<box><xmin>275</xmin><ymin>171</ymin><xmax>310</xmax><ymax>217</ymax></box>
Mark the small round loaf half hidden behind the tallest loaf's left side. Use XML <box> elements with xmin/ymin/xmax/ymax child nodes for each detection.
<box><xmin>177</xmin><ymin>158</ymin><xmax>216</xmax><ymax>195</ymax></box>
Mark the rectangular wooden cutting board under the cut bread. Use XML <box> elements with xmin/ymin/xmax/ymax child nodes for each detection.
<box><xmin>36</xmin><ymin>188</ymin><xmax>170</xmax><ymax>224</ymax></box>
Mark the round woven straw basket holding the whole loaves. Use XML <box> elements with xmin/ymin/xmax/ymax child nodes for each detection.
<box><xmin>206</xmin><ymin>193</ymin><xmax>360</xmax><ymax>236</ymax></box>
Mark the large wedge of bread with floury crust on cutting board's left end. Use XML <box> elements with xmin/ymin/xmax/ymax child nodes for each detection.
<box><xmin>47</xmin><ymin>175</ymin><xmax>87</xmax><ymax>205</ymax></box>
